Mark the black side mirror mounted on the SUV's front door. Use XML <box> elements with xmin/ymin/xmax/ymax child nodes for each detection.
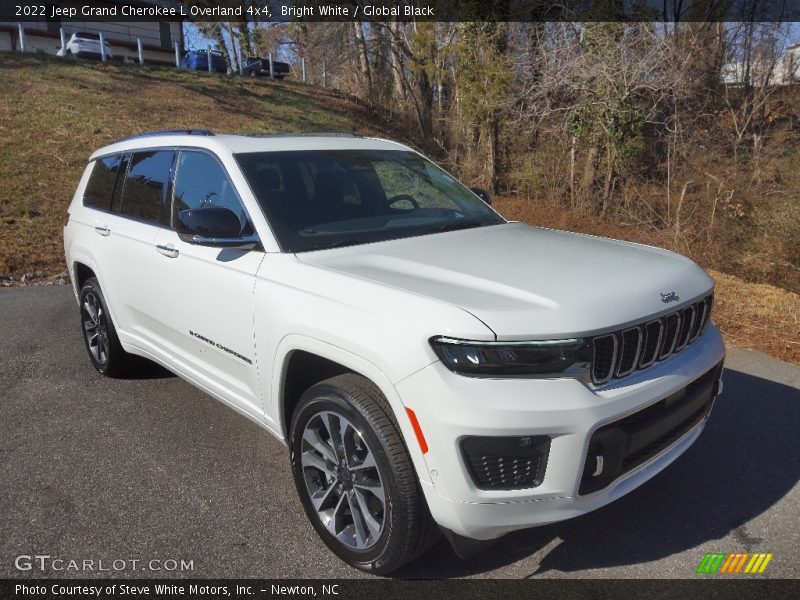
<box><xmin>175</xmin><ymin>206</ymin><xmax>259</xmax><ymax>248</ymax></box>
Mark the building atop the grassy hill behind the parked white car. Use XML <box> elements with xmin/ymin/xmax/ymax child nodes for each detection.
<box><xmin>0</xmin><ymin>0</ymin><xmax>184</xmax><ymax>64</ymax></box>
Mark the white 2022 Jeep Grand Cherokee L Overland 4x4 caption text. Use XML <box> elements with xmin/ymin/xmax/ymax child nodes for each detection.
<box><xmin>14</xmin><ymin>2</ymin><xmax>436</xmax><ymax>20</ymax></box>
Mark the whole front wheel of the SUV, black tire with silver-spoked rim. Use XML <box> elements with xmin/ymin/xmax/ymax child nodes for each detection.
<box><xmin>290</xmin><ymin>373</ymin><xmax>439</xmax><ymax>574</ymax></box>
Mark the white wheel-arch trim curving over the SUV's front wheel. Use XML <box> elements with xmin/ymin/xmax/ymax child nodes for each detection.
<box><xmin>267</xmin><ymin>333</ymin><xmax>431</xmax><ymax>483</ymax></box>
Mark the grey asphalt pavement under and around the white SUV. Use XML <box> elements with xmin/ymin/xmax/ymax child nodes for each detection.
<box><xmin>0</xmin><ymin>286</ymin><xmax>800</xmax><ymax>578</ymax></box>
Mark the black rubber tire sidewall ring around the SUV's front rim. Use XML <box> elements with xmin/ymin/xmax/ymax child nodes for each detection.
<box><xmin>290</xmin><ymin>384</ymin><xmax>401</xmax><ymax>572</ymax></box>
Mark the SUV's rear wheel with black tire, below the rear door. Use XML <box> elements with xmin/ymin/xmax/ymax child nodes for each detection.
<box><xmin>79</xmin><ymin>277</ymin><xmax>136</xmax><ymax>377</ymax></box>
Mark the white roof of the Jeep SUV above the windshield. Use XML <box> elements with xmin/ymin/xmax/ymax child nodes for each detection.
<box><xmin>91</xmin><ymin>130</ymin><xmax>410</xmax><ymax>158</ymax></box>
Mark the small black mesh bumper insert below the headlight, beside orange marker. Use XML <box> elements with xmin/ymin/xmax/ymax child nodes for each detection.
<box><xmin>461</xmin><ymin>436</ymin><xmax>550</xmax><ymax>490</ymax></box>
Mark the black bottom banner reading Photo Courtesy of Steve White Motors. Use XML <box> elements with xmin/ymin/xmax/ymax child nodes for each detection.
<box><xmin>0</xmin><ymin>577</ymin><xmax>800</xmax><ymax>600</ymax></box>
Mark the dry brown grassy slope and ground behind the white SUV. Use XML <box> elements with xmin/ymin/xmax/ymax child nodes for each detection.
<box><xmin>0</xmin><ymin>53</ymin><xmax>800</xmax><ymax>363</ymax></box>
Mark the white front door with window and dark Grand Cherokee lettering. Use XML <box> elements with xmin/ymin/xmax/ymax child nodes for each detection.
<box><xmin>154</xmin><ymin>150</ymin><xmax>264</xmax><ymax>418</ymax></box>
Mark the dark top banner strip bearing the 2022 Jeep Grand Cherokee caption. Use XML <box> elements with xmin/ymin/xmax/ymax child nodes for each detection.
<box><xmin>0</xmin><ymin>0</ymin><xmax>800</xmax><ymax>23</ymax></box>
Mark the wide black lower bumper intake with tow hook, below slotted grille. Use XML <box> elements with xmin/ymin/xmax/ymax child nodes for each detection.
<box><xmin>579</xmin><ymin>363</ymin><xmax>722</xmax><ymax>494</ymax></box>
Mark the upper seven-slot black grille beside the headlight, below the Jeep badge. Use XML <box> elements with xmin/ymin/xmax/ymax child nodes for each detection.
<box><xmin>591</xmin><ymin>296</ymin><xmax>713</xmax><ymax>385</ymax></box>
